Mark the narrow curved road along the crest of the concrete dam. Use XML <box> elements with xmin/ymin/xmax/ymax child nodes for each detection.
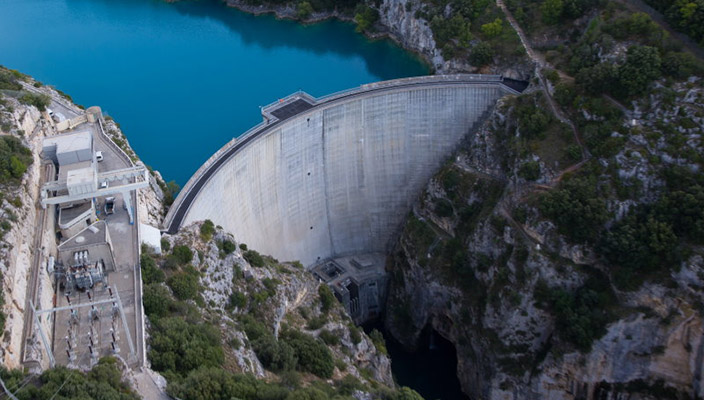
<box><xmin>166</xmin><ymin>75</ymin><xmax>518</xmax><ymax>234</ymax></box>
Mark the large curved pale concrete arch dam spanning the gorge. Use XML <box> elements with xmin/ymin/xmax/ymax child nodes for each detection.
<box><xmin>165</xmin><ymin>75</ymin><xmax>524</xmax><ymax>266</ymax></box>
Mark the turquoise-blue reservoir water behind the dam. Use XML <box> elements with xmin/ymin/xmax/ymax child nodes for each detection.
<box><xmin>0</xmin><ymin>0</ymin><xmax>428</xmax><ymax>185</ymax></box>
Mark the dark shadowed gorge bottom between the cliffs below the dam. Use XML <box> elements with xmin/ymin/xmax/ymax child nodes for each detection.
<box><xmin>364</xmin><ymin>322</ymin><xmax>469</xmax><ymax>400</ymax></box>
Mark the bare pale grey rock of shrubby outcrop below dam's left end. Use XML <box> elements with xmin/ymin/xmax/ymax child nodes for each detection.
<box><xmin>164</xmin><ymin>223</ymin><xmax>394</xmax><ymax>387</ymax></box>
